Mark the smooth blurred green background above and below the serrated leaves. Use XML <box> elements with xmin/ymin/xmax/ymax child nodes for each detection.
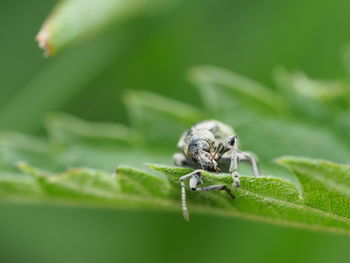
<box><xmin>0</xmin><ymin>0</ymin><xmax>350</xmax><ymax>262</ymax></box>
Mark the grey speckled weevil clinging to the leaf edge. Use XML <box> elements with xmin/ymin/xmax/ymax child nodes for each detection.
<box><xmin>173</xmin><ymin>120</ymin><xmax>260</xmax><ymax>220</ymax></box>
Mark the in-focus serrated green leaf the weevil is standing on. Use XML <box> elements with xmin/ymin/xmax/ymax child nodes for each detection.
<box><xmin>0</xmin><ymin>158</ymin><xmax>350</xmax><ymax>234</ymax></box>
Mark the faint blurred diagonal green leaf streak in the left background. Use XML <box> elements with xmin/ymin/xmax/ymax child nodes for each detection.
<box><xmin>0</xmin><ymin>32</ymin><xmax>127</xmax><ymax>132</ymax></box>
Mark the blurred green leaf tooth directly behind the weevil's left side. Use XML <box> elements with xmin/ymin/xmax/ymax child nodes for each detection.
<box><xmin>124</xmin><ymin>91</ymin><xmax>206</xmax><ymax>148</ymax></box>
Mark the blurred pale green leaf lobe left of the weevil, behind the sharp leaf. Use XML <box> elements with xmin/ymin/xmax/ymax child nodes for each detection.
<box><xmin>45</xmin><ymin>113</ymin><xmax>170</xmax><ymax>172</ymax></box>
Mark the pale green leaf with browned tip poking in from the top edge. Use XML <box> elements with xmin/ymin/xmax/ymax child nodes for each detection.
<box><xmin>37</xmin><ymin>0</ymin><xmax>177</xmax><ymax>56</ymax></box>
